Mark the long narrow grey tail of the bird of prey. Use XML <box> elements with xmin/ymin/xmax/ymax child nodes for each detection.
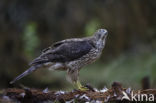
<box><xmin>10</xmin><ymin>65</ymin><xmax>40</xmax><ymax>84</ymax></box>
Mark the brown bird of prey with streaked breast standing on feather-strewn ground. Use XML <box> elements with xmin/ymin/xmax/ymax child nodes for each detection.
<box><xmin>10</xmin><ymin>29</ymin><xmax>108</xmax><ymax>90</ymax></box>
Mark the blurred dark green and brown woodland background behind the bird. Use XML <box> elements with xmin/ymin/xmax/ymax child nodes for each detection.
<box><xmin>0</xmin><ymin>0</ymin><xmax>156</xmax><ymax>90</ymax></box>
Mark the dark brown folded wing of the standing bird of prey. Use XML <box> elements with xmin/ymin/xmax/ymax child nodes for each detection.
<box><xmin>31</xmin><ymin>41</ymin><xmax>93</xmax><ymax>65</ymax></box>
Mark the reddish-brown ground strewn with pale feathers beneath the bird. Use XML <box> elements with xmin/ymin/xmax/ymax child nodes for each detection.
<box><xmin>0</xmin><ymin>82</ymin><xmax>156</xmax><ymax>103</ymax></box>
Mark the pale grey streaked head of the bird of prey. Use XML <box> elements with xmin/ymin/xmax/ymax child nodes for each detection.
<box><xmin>94</xmin><ymin>29</ymin><xmax>108</xmax><ymax>49</ymax></box>
